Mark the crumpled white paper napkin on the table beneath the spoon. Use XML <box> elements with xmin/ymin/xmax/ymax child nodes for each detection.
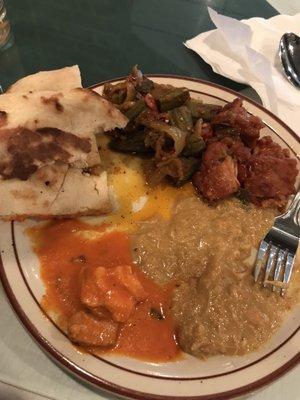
<box><xmin>185</xmin><ymin>8</ymin><xmax>300</xmax><ymax>135</ymax></box>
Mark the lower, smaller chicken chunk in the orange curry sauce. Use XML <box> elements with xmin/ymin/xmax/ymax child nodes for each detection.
<box><xmin>68</xmin><ymin>311</ymin><xmax>119</xmax><ymax>347</ymax></box>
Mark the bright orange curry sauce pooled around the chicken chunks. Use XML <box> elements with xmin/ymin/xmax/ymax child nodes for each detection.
<box><xmin>29</xmin><ymin>220</ymin><xmax>179</xmax><ymax>362</ymax></box>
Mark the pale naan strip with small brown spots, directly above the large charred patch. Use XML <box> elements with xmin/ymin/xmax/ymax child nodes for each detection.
<box><xmin>0</xmin><ymin>88</ymin><xmax>127</xmax><ymax>136</ymax></box>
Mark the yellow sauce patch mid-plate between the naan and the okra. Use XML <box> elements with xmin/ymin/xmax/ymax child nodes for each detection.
<box><xmin>100</xmin><ymin>138</ymin><xmax>194</xmax><ymax>231</ymax></box>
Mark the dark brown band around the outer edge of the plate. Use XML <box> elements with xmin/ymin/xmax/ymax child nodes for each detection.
<box><xmin>0</xmin><ymin>74</ymin><xmax>300</xmax><ymax>400</ymax></box>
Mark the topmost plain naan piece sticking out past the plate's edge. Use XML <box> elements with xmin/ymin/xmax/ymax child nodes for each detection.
<box><xmin>6</xmin><ymin>65</ymin><xmax>82</xmax><ymax>93</ymax></box>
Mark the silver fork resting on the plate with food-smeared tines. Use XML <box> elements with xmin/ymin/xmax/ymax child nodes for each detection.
<box><xmin>254</xmin><ymin>190</ymin><xmax>300</xmax><ymax>296</ymax></box>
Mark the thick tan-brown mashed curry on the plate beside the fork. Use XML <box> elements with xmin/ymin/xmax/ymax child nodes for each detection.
<box><xmin>133</xmin><ymin>197</ymin><xmax>300</xmax><ymax>357</ymax></box>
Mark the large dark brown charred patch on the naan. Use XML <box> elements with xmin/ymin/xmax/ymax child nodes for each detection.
<box><xmin>0</xmin><ymin>127</ymin><xmax>91</xmax><ymax>180</ymax></box>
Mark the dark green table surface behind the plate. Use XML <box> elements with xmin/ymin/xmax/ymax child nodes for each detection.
<box><xmin>0</xmin><ymin>0</ymin><xmax>277</xmax><ymax>90</ymax></box>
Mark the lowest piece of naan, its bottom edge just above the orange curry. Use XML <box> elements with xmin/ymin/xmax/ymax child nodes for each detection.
<box><xmin>0</xmin><ymin>164</ymin><xmax>111</xmax><ymax>220</ymax></box>
